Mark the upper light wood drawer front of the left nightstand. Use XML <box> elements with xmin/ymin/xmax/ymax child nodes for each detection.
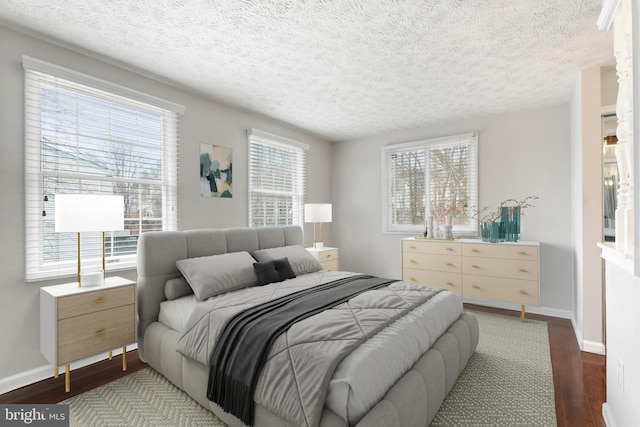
<box><xmin>58</xmin><ymin>286</ymin><xmax>135</xmax><ymax>319</ymax></box>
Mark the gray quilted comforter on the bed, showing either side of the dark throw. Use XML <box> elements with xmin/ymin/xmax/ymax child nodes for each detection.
<box><xmin>172</xmin><ymin>273</ymin><xmax>448</xmax><ymax>427</ymax></box>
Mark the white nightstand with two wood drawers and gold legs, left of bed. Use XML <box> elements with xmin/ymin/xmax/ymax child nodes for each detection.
<box><xmin>40</xmin><ymin>277</ymin><xmax>136</xmax><ymax>392</ymax></box>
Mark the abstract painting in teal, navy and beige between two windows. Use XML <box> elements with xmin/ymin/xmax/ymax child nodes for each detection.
<box><xmin>200</xmin><ymin>142</ymin><xmax>233</xmax><ymax>197</ymax></box>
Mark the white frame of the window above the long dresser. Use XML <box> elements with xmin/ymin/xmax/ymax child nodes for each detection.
<box><xmin>381</xmin><ymin>132</ymin><xmax>478</xmax><ymax>237</ymax></box>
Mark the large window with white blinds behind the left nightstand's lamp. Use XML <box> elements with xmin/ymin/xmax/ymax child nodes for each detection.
<box><xmin>23</xmin><ymin>57</ymin><xmax>183</xmax><ymax>281</ymax></box>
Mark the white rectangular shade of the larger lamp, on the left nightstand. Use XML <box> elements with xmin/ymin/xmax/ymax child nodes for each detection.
<box><xmin>55</xmin><ymin>194</ymin><xmax>124</xmax><ymax>233</ymax></box>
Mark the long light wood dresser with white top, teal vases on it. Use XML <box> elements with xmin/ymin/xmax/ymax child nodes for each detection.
<box><xmin>402</xmin><ymin>238</ymin><xmax>540</xmax><ymax>318</ymax></box>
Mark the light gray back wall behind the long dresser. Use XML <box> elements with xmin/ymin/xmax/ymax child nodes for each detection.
<box><xmin>332</xmin><ymin>104</ymin><xmax>573</xmax><ymax>317</ymax></box>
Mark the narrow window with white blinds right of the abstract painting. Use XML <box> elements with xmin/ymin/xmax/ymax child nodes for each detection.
<box><xmin>248</xmin><ymin>129</ymin><xmax>309</xmax><ymax>227</ymax></box>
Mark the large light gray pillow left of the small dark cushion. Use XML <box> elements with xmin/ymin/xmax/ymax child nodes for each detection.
<box><xmin>176</xmin><ymin>252</ymin><xmax>258</xmax><ymax>301</ymax></box>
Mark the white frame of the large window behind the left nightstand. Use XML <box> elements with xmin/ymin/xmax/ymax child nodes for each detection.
<box><xmin>23</xmin><ymin>56</ymin><xmax>184</xmax><ymax>282</ymax></box>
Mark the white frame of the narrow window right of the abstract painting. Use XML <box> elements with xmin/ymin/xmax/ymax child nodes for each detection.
<box><xmin>247</xmin><ymin>128</ymin><xmax>309</xmax><ymax>227</ymax></box>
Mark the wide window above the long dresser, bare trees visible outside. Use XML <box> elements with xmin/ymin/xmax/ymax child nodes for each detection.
<box><xmin>382</xmin><ymin>133</ymin><xmax>478</xmax><ymax>235</ymax></box>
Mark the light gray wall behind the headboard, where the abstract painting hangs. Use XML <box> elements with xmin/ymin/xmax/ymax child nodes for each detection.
<box><xmin>0</xmin><ymin>26</ymin><xmax>332</xmax><ymax>389</ymax></box>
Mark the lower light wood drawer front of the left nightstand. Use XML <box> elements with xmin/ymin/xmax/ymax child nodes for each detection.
<box><xmin>58</xmin><ymin>304</ymin><xmax>135</xmax><ymax>364</ymax></box>
